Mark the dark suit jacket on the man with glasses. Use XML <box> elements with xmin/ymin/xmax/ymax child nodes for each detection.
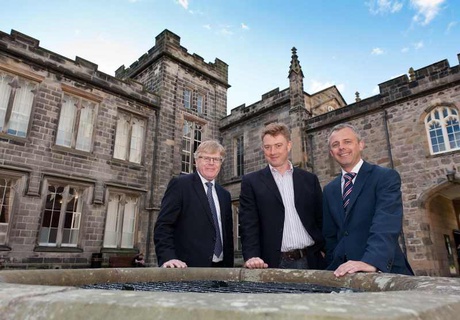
<box><xmin>153</xmin><ymin>172</ymin><xmax>234</xmax><ymax>267</ymax></box>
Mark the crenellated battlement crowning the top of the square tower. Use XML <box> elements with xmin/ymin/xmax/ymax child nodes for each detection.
<box><xmin>115</xmin><ymin>29</ymin><xmax>228</xmax><ymax>86</ymax></box>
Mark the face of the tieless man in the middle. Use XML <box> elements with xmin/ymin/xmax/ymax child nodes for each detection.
<box><xmin>262</xmin><ymin>134</ymin><xmax>291</xmax><ymax>169</ymax></box>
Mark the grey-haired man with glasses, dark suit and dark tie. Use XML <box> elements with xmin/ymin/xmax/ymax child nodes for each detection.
<box><xmin>153</xmin><ymin>140</ymin><xmax>234</xmax><ymax>268</ymax></box>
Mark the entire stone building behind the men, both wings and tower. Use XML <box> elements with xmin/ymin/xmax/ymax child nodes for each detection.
<box><xmin>0</xmin><ymin>30</ymin><xmax>460</xmax><ymax>276</ymax></box>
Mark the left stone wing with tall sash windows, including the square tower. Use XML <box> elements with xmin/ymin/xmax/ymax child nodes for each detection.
<box><xmin>0</xmin><ymin>30</ymin><xmax>229</xmax><ymax>268</ymax></box>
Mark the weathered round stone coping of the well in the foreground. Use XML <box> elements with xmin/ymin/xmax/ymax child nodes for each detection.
<box><xmin>0</xmin><ymin>268</ymin><xmax>460</xmax><ymax>320</ymax></box>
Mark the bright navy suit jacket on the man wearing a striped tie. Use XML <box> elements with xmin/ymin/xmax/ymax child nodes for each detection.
<box><xmin>323</xmin><ymin>162</ymin><xmax>413</xmax><ymax>275</ymax></box>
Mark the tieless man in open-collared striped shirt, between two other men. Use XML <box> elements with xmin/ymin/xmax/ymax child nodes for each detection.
<box><xmin>239</xmin><ymin>123</ymin><xmax>324</xmax><ymax>269</ymax></box>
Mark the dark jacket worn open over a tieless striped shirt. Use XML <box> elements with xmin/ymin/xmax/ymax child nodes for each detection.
<box><xmin>239</xmin><ymin>166</ymin><xmax>324</xmax><ymax>269</ymax></box>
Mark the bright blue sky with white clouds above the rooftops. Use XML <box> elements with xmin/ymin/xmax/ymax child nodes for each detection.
<box><xmin>0</xmin><ymin>0</ymin><xmax>460</xmax><ymax>112</ymax></box>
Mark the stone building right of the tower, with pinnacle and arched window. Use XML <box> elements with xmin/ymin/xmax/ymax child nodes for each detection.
<box><xmin>221</xmin><ymin>49</ymin><xmax>460</xmax><ymax>276</ymax></box>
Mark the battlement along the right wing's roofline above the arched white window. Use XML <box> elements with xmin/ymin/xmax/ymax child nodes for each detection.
<box><xmin>379</xmin><ymin>54</ymin><xmax>460</xmax><ymax>103</ymax></box>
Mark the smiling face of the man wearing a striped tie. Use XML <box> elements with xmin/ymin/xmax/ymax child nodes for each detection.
<box><xmin>329</xmin><ymin>128</ymin><xmax>364</xmax><ymax>172</ymax></box>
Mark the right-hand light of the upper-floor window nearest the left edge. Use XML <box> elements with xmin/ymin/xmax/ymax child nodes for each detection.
<box><xmin>8</xmin><ymin>80</ymin><xmax>36</xmax><ymax>137</ymax></box>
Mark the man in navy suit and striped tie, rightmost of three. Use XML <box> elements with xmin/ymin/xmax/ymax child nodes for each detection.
<box><xmin>323</xmin><ymin>124</ymin><xmax>413</xmax><ymax>277</ymax></box>
